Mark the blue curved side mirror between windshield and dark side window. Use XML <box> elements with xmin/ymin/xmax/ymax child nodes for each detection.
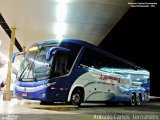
<box><xmin>46</xmin><ymin>47</ymin><xmax>71</xmax><ymax>61</ymax></box>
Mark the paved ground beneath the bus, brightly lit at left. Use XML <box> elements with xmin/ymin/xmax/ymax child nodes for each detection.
<box><xmin>0</xmin><ymin>96</ymin><xmax>160</xmax><ymax>120</ymax></box>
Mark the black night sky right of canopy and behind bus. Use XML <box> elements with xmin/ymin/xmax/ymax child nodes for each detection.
<box><xmin>99</xmin><ymin>0</ymin><xmax>160</xmax><ymax>96</ymax></box>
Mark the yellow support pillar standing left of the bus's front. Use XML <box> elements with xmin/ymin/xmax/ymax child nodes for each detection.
<box><xmin>3</xmin><ymin>28</ymin><xmax>16</xmax><ymax>101</ymax></box>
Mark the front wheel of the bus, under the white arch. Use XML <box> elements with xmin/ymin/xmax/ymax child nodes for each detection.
<box><xmin>71</xmin><ymin>89</ymin><xmax>82</xmax><ymax>106</ymax></box>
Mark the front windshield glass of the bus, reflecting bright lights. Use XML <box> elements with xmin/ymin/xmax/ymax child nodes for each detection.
<box><xmin>18</xmin><ymin>46</ymin><xmax>53</xmax><ymax>81</ymax></box>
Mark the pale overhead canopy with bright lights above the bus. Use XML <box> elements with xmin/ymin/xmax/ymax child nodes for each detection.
<box><xmin>0</xmin><ymin>0</ymin><xmax>133</xmax><ymax>47</ymax></box>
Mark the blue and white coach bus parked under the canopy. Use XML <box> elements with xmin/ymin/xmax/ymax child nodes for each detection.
<box><xmin>12</xmin><ymin>39</ymin><xmax>150</xmax><ymax>106</ymax></box>
